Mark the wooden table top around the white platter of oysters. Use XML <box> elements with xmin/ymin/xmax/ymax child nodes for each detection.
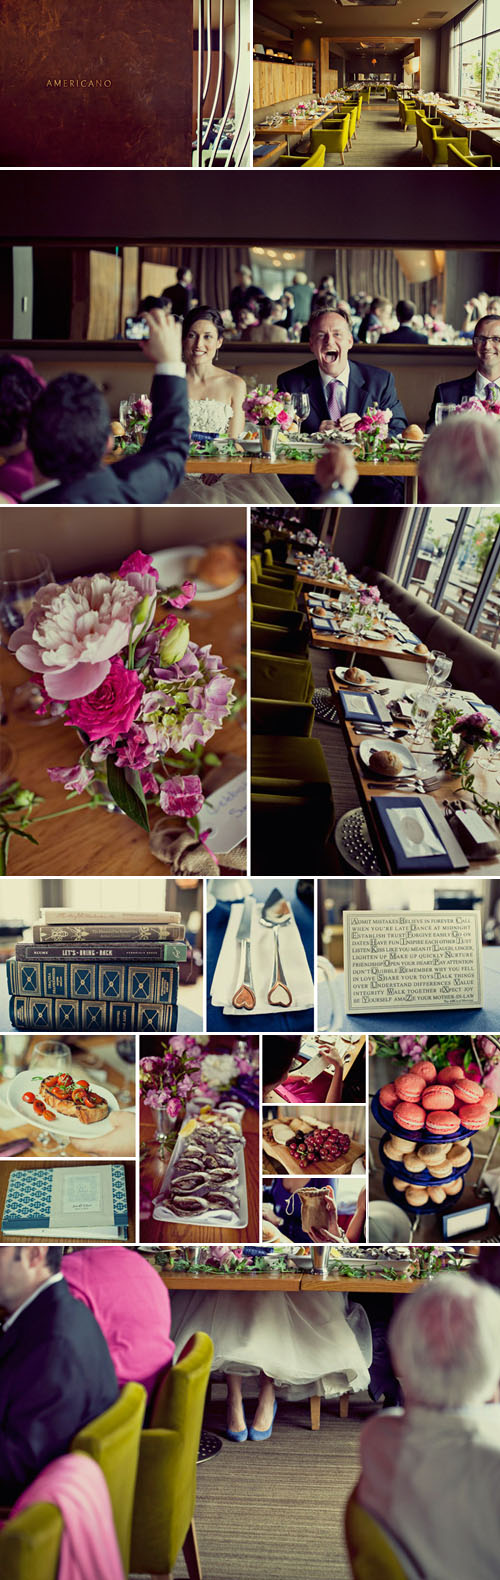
<box><xmin>141</xmin><ymin>1103</ymin><xmax>259</xmax><ymax>1245</ymax></box>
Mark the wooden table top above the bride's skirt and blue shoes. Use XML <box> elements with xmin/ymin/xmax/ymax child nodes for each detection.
<box><xmin>160</xmin><ymin>1269</ymin><xmax>421</xmax><ymax>1294</ymax></box>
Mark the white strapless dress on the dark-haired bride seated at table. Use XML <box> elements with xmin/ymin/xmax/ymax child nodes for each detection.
<box><xmin>169</xmin><ymin>400</ymin><xmax>293</xmax><ymax>504</ymax></box>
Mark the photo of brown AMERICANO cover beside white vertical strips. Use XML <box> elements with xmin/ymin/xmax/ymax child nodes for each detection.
<box><xmin>0</xmin><ymin>0</ymin><xmax>252</xmax><ymax>169</ymax></box>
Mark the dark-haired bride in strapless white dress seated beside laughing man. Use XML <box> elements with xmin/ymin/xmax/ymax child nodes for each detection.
<box><xmin>169</xmin><ymin>307</ymin><xmax>293</xmax><ymax>504</ymax></box>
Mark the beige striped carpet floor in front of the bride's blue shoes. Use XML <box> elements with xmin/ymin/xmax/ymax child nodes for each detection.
<box><xmin>174</xmin><ymin>1398</ymin><xmax>368</xmax><ymax>1580</ymax></box>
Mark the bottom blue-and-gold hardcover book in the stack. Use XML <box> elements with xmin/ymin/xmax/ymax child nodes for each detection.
<box><xmin>9</xmin><ymin>994</ymin><xmax>177</xmax><ymax>1032</ymax></box>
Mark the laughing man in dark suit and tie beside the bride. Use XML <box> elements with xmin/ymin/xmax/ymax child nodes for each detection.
<box><xmin>277</xmin><ymin>308</ymin><xmax>407</xmax><ymax>504</ymax></box>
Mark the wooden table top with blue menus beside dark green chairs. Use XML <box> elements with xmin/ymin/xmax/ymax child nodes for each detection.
<box><xmin>328</xmin><ymin>666</ymin><xmax>500</xmax><ymax>872</ymax></box>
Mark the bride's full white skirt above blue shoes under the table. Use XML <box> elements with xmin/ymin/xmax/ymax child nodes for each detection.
<box><xmin>171</xmin><ymin>1289</ymin><xmax>372</xmax><ymax>1398</ymax></box>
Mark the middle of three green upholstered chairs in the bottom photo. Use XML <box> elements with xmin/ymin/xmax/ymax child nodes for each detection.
<box><xmin>70</xmin><ymin>1383</ymin><xmax>147</xmax><ymax>1580</ymax></box>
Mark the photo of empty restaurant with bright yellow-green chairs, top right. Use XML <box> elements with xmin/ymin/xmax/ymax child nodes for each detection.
<box><xmin>253</xmin><ymin>0</ymin><xmax>500</xmax><ymax>169</ymax></box>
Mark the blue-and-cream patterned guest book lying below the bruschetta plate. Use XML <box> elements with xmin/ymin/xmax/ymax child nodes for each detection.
<box><xmin>2</xmin><ymin>1163</ymin><xmax>128</xmax><ymax>1242</ymax></box>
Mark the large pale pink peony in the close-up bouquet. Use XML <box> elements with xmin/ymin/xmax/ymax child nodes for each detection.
<box><xmin>9</xmin><ymin>574</ymin><xmax>138</xmax><ymax>702</ymax></box>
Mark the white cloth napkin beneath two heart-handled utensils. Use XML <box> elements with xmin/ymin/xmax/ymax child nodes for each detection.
<box><xmin>210</xmin><ymin>902</ymin><xmax>315</xmax><ymax>1021</ymax></box>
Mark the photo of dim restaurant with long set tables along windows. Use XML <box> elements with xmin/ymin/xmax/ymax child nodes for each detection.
<box><xmin>252</xmin><ymin>506</ymin><xmax>500</xmax><ymax>877</ymax></box>
